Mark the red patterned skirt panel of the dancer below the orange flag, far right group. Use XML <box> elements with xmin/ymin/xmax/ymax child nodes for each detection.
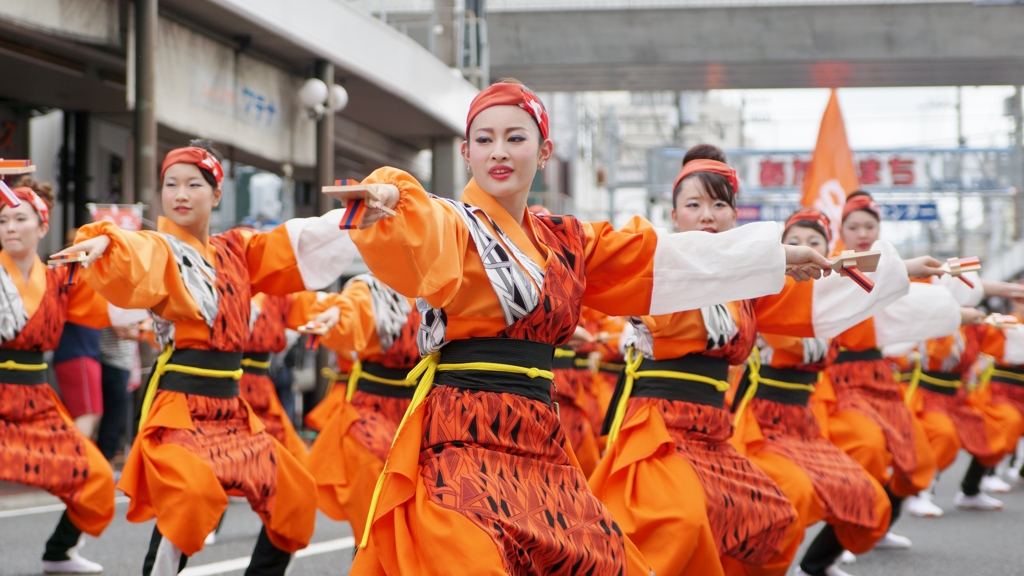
<box><xmin>825</xmin><ymin>360</ymin><xmax>918</xmax><ymax>478</ymax></box>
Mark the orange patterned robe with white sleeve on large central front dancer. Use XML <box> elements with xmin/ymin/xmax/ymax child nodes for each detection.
<box><xmin>351</xmin><ymin>168</ymin><xmax>782</xmax><ymax>576</ymax></box>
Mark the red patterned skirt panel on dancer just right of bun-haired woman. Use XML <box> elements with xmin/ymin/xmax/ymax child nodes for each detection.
<box><xmin>749</xmin><ymin>398</ymin><xmax>879</xmax><ymax>530</ymax></box>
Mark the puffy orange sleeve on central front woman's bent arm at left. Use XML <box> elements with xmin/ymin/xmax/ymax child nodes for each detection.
<box><xmin>349</xmin><ymin>167</ymin><xmax>470</xmax><ymax>307</ymax></box>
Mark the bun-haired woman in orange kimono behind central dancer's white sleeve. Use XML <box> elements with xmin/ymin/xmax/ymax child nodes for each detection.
<box><xmin>590</xmin><ymin>147</ymin><xmax>925</xmax><ymax>576</ymax></box>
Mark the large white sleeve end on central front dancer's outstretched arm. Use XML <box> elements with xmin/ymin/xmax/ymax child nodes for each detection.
<box><xmin>650</xmin><ymin>222</ymin><xmax>785</xmax><ymax>316</ymax></box>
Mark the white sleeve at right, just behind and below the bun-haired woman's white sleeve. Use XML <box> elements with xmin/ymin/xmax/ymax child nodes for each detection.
<box><xmin>874</xmin><ymin>282</ymin><xmax>961</xmax><ymax>346</ymax></box>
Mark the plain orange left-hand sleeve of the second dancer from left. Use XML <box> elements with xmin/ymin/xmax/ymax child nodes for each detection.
<box><xmin>75</xmin><ymin>222</ymin><xmax>203</xmax><ymax>322</ymax></box>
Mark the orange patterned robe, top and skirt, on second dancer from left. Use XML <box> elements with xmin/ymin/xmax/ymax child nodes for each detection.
<box><xmin>78</xmin><ymin>213</ymin><xmax>337</xmax><ymax>556</ymax></box>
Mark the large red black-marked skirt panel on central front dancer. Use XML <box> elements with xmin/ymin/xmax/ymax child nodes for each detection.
<box><xmin>420</xmin><ymin>386</ymin><xmax>626</xmax><ymax>574</ymax></box>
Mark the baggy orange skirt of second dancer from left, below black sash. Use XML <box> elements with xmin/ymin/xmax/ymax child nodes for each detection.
<box><xmin>118</xmin><ymin>390</ymin><xmax>316</xmax><ymax>556</ymax></box>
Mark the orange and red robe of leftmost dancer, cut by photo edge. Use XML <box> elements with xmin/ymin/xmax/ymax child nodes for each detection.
<box><xmin>0</xmin><ymin>251</ymin><xmax>114</xmax><ymax>537</ymax></box>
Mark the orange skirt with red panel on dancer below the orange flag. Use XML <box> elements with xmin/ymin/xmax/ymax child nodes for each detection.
<box><xmin>825</xmin><ymin>360</ymin><xmax>936</xmax><ymax>496</ymax></box>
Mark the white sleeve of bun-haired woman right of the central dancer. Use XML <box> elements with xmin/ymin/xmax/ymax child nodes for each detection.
<box><xmin>811</xmin><ymin>240</ymin><xmax>913</xmax><ymax>338</ymax></box>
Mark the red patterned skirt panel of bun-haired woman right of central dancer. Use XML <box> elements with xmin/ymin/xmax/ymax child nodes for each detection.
<box><xmin>626</xmin><ymin>398</ymin><xmax>795</xmax><ymax>565</ymax></box>
